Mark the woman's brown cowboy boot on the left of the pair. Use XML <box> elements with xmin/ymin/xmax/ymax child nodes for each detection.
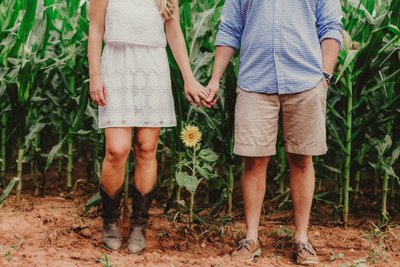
<box><xmin>100</xmin><ymin>185</ymin><xmax>123</xmax><ymax>251</ymax></box>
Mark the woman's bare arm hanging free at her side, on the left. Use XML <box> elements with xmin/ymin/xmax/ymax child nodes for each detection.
<box><xmin>88</xmin><ymin>0</ymin><xmax>108</xmax><ymax>106</ymax></box>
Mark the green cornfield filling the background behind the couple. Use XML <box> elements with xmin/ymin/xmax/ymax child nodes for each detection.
<box><xmin>0</xmin><ymin>0</ymin><xmax>400</xmax><ymax>258</ymax></box>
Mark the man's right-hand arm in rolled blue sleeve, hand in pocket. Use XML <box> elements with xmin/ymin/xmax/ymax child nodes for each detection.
<box><xmin>316</xmin><ymin>0</ymin><xmax>343</xmax><ymax>80</ymax></box>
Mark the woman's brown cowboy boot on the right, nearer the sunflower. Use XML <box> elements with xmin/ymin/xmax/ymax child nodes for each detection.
<box><xmin>128</xmin><ymin>187</ymin><xmax>155</xmax><ymax>254</ymax></box>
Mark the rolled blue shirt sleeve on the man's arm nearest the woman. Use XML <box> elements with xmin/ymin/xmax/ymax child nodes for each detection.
<box><xmin>215</xmin><ymin>0</ymin><xmax>243</xmax><ymax>48</ymax></box>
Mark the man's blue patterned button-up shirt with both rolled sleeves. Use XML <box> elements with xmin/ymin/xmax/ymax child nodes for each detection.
<box><xmin>216</xmin><ymin>0</ymin><xmax>342</xmax><ymax>94</ymax></box>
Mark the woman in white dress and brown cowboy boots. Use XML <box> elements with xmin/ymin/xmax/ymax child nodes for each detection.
<box><xmin>88</xmin><ymin>0</ymin><xmax>208</xmax><ymax>253</ymax></box>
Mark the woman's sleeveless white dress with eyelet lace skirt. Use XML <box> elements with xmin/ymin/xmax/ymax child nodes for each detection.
<box><xmin>99</xmin><ymin>0</ymin><xmax>176</xmax><ymax>128</ymax></box>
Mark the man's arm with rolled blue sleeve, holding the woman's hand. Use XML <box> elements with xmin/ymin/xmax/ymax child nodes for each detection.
<box><xmin>203</xmin><ymin>0</ymin><xmax>243</xmax><ymax>107</ymax></box>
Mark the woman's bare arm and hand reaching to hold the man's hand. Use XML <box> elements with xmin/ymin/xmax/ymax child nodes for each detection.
<box><xmin>165</xmin><ymin>1</ymin><xmax>208</xmax><ymax>106</ymax></box>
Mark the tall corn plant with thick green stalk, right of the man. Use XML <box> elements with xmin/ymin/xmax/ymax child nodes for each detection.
<box><xmin>329</xmin><ymin>1</ymin><xmax>400</xmax><ymax>225</ymax></box>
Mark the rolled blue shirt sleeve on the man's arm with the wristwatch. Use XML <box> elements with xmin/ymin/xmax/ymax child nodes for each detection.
<box><xmin>317</xmin><ymin>0</ymin><xmax>343</xmax><ymax>47</ymax></box>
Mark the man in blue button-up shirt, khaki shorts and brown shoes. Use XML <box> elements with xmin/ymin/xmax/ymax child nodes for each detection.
<box><xmin>204</xmin><ymin>0</ymin><xmax>342</xmax><ymax>265</ymax></box>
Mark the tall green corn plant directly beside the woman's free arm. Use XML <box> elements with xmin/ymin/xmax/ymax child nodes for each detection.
<box><xmin>46</xmin><ymin>0</ymin><xmax>90</xmax><ymax>193</ymax></box>
